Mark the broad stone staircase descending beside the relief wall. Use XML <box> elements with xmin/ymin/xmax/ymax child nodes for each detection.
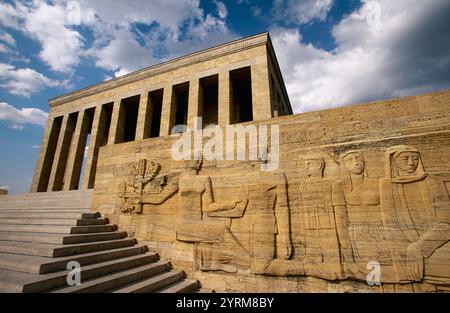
<box><xmin>0</xmin><ymin>191</ymin><xmax>210</xmax><ymax>293</ymax></box>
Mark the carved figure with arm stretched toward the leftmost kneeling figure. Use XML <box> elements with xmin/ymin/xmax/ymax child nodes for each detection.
<box><xmin>209</xmin><ymin>155</ymin><xmax>304</xmax><ymax>276</ymax></box>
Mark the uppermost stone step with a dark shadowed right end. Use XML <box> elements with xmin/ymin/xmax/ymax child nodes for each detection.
<box><xmin>0</xmin><ymin>210</ymin><xmax>100</xmax><ymax>220</ymax></box>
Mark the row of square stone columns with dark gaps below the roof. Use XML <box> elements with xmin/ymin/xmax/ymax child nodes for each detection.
<box><xmin>31</xmin><ymin>63</ymin><xmax>273</xmax><ymax>192</ymax></box>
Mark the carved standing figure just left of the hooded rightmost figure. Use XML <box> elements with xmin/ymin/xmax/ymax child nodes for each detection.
<box><xmin>332</xmin><ymin>150</ymin><xmax>392</xmax><ymax>280</ymax></box>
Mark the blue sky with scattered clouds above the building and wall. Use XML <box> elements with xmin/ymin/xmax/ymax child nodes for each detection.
<box><xmin>0</xmin><ymin>0</ymin><xmax>450</xmax><ymax>193</ymax></box>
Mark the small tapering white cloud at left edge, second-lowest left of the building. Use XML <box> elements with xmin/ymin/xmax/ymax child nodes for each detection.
<box><xmin>0</xmin><ymin>63</ymin><xmax>63</xmax><ymax>97</ymax></box>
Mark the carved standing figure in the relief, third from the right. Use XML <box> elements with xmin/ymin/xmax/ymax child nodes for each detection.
<box><xmin>299</xmin><ymin>153</ymin><xmax>342</xmax><ymax>280</ymax></box>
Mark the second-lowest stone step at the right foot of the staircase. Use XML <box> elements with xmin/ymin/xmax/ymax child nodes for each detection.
<box><xmin>113</xmin><ymin>271</ymin><xmax>185</xmax><ymax>293</ymax></box>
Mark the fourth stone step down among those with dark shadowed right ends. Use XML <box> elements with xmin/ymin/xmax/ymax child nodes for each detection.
<box><xmin>0</xmin><ymin>232</ymin><xmax>127</xmax><ymax>244</ymax></box>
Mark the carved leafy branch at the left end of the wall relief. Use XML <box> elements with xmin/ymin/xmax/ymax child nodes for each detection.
<box><xmin>119</xmin><ymin>159</ymin><xmax>178</xmax><ymax>214</ymax></box>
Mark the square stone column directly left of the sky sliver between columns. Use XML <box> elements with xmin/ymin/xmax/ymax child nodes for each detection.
<box><xmin>64</xmin><ymin>110</ymin><xmax>90</xmax><ymax>190</ymax></box>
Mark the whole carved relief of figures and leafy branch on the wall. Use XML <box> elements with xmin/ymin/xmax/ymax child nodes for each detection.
<box><xmin>115</xmin><ymin>146</ymin><xmax>450</xmax><ymax>283</ymax></box>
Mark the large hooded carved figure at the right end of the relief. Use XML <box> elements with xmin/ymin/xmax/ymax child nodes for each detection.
<box><xmin>380</xmin><ymin>146</ymin><xmax>450</xmax><ymax>282</ymax></box>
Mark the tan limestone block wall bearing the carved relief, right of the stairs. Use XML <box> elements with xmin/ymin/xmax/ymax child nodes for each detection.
<box><xmin>92</xmin><ymin>91</ymin><xmax>450</xmax><ymax>292</ymax></box>
